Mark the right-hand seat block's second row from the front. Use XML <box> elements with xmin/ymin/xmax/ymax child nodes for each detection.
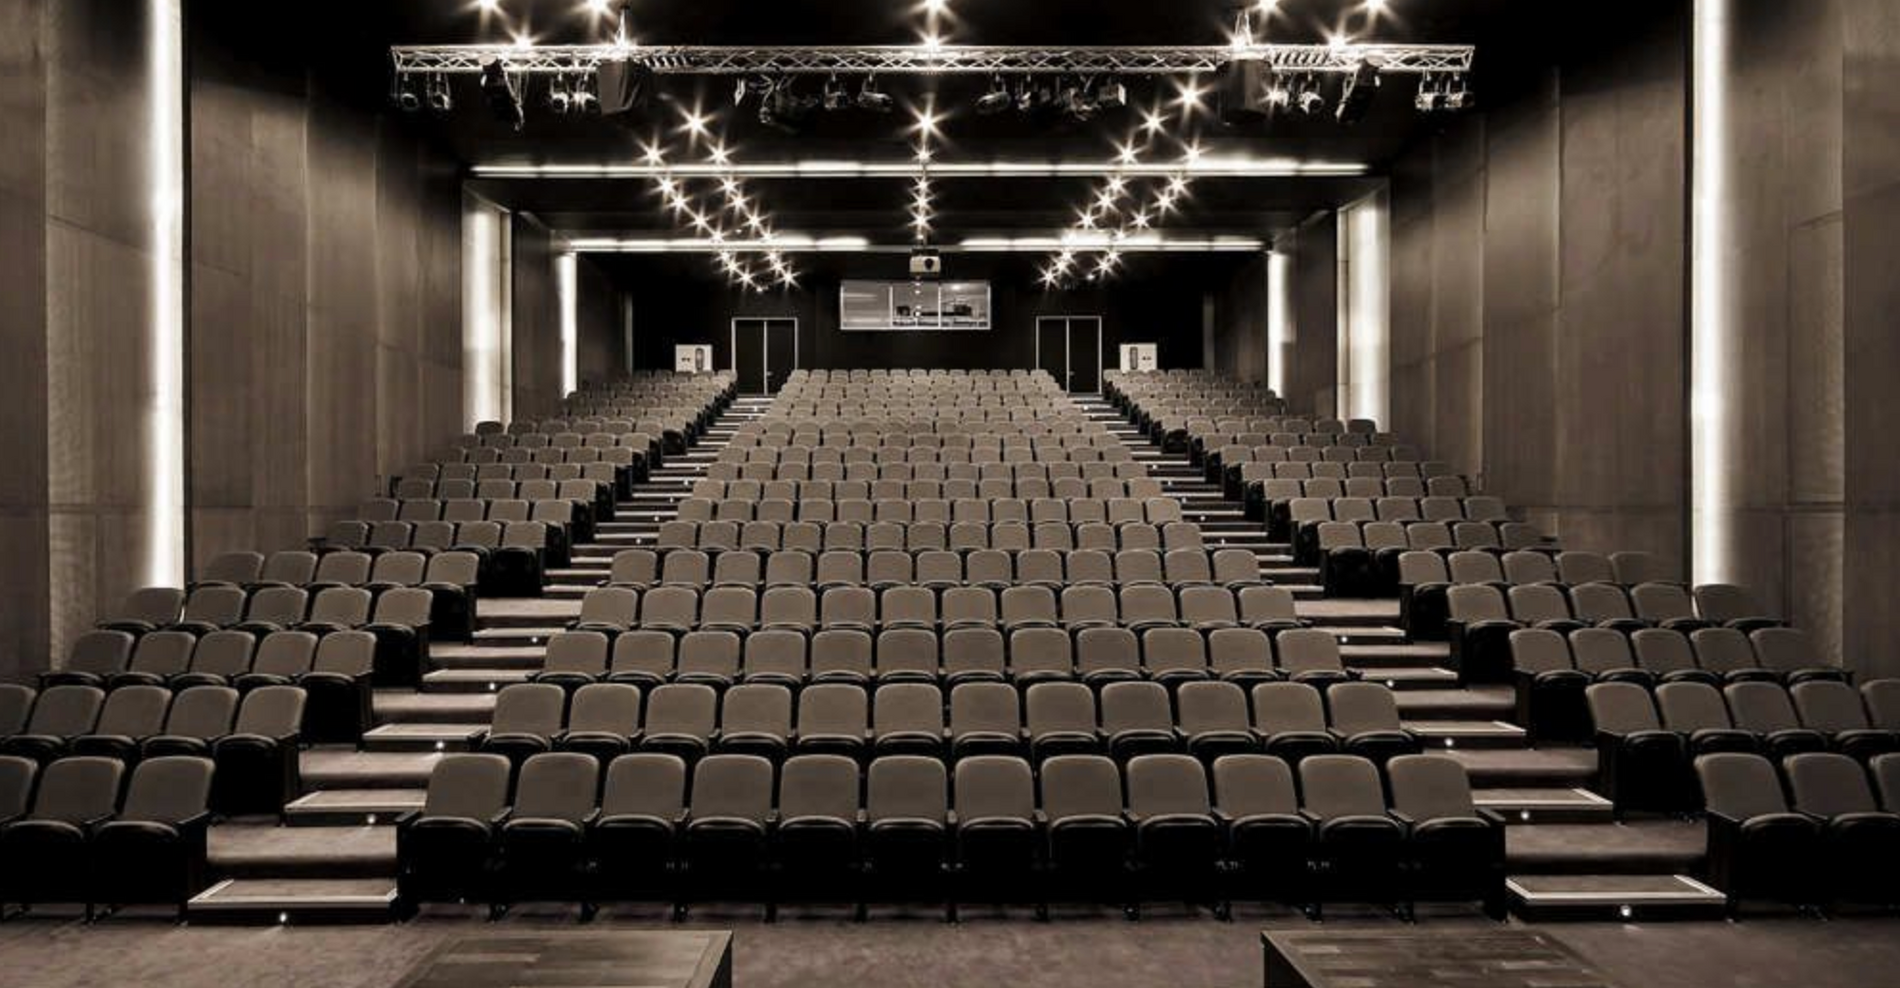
<box><xmin>1585</xmin><ymin>680</ymin><xmax>1900</xmax><ymax>813</ymax></box>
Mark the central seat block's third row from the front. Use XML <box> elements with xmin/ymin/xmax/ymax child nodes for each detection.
<box><xmin>534</xmin><ymin>625</ymin><xmax>1359</xmax><ymax>688</ymax></box>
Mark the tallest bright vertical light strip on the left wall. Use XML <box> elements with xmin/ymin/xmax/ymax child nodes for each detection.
<box><xmin>144</xmin><ymin>0</ymin><xmax>184</xmax><ymax>587</ymax></box>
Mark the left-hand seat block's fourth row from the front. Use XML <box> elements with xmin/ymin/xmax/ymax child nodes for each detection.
<box><xmin>95</xmin><ymin>583</ymin><xmax>435</xmax><ymax>686</ymax></box>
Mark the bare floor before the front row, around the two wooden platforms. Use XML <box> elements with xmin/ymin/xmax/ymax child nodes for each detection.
<box><xmin>0</xmin><ymin>906</ymin><xmax>1900</xmax><ymax>988</ymax></box>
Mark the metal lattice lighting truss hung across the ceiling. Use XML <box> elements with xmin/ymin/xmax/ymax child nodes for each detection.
<box><xmin>390</xmin><ymin>44</ymin><xmax>1473</xmax><ymax>76</ymax></box>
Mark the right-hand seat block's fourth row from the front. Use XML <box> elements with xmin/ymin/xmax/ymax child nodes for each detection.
<box><xmin>1444</xmin><ymin>583</ymin><xmax>1801</xmax><ymax>682</ymax></box>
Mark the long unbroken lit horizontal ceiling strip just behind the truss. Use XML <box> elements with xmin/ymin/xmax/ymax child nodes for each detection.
<box><xmin>473</xmin><ymin>156</ymin><xmax>1368</xmax><ymax>181</ymax></box>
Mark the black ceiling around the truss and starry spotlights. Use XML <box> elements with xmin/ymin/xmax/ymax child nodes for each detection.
<box><xmin>213</xmin><ymin>0</ymin><xmax>1672</xmax><ymax>266</ymax></box>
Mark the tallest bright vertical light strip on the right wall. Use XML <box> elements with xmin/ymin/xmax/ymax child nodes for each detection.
<box><xmin>1689</xmin><ymin>0</ymin><xmax>1735</xmax><ymax>583</ymax></box>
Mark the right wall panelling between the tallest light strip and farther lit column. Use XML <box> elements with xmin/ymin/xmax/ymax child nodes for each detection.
<box><xmin>1391</xmin><ymin>5</ymin><xmax>1687</xmax><ymax>568</ymax></box>
